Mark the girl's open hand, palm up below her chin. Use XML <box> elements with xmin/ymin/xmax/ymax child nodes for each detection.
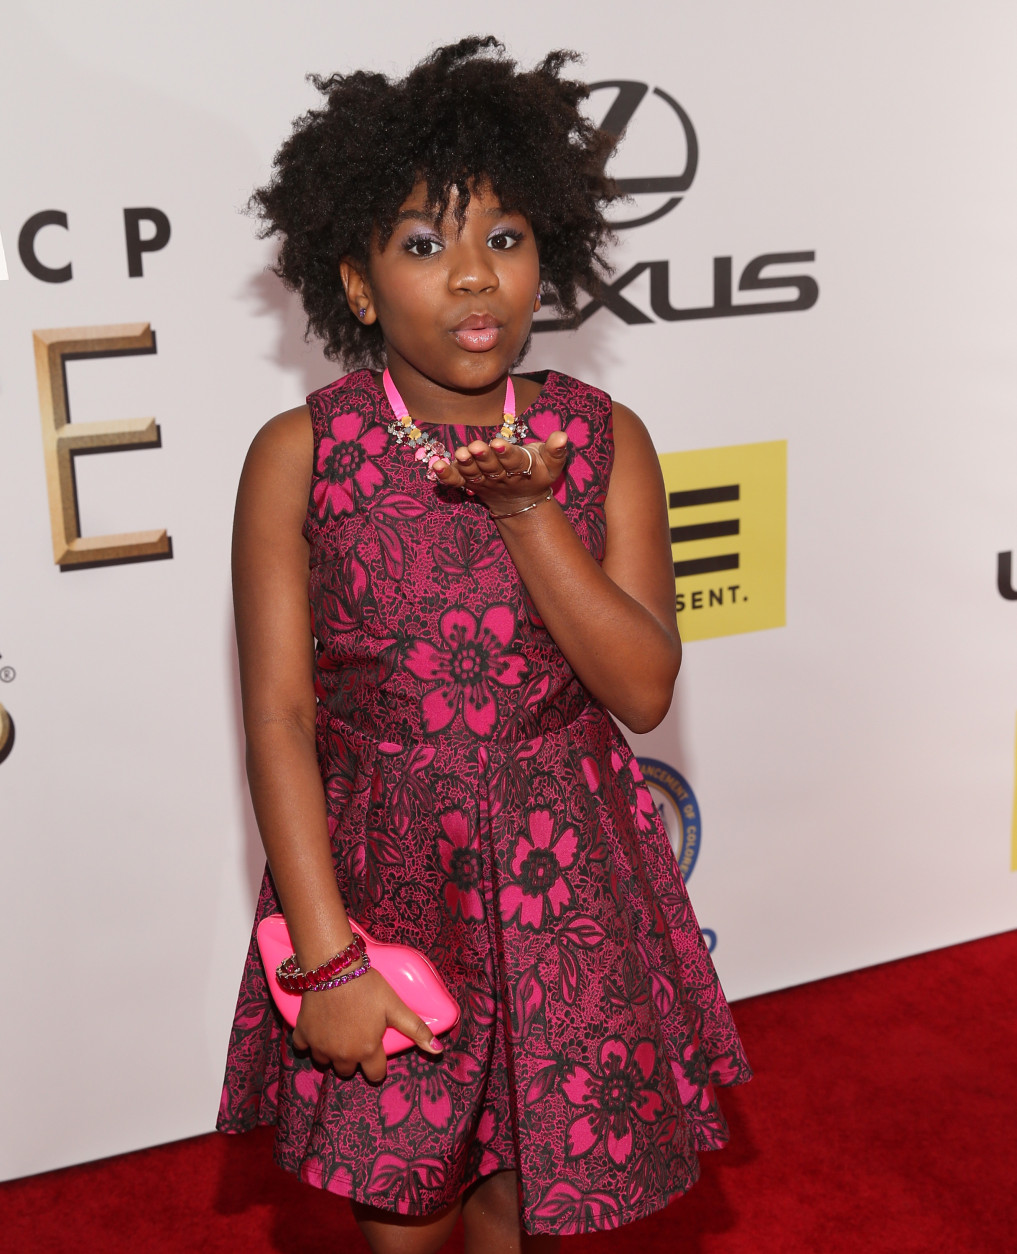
<box><xmin>431</xmin><ymin>431</ymin><xmax>568</xmax><ymax>514</ymax></box>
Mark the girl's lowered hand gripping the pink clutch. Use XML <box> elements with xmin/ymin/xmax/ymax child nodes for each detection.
<box><xmin>293</xmin><ymin>971</ymin><xmax>443</xmax><ymax>1082</ymax></box>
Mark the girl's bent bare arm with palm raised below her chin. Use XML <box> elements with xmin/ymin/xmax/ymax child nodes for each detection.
<box><xmin>440</xmin><ymin>405</ymin><xmax>681</xmax><ymax>731</ymax></box>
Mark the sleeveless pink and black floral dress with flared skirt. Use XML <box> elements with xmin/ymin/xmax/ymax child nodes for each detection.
<box><xmin>218</xmin><ymin>370</ymin><xmax>751</xmax><ymax>1234</ymax></box>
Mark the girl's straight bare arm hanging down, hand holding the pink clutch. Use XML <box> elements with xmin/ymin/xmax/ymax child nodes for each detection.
<box><xmin>233</xmin><ymin>408</ymin><xmax>431</xmax><ymax>1078</ymax></box>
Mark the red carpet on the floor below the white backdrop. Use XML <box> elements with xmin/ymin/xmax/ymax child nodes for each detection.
<box><xmin>0</xmin><ymin>932</ymin><xmax>1017</xmax><ymax>1254</ymax></box>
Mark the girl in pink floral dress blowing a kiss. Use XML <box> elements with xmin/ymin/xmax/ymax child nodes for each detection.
<box><xmin>219</xmin><ymin>39</ymin><xmax>749</xmax><ymax>1254</ymax></box>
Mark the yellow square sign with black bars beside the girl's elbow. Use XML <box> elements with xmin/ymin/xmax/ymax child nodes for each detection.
<box><xmin>661</xmin><ymin>440</ymin><xmax>788</xmax><ymax>641</ymax></box>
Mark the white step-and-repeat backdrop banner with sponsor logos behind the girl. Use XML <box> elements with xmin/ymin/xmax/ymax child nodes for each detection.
<box><xmin>0</xmin><ymin>0</ymin><xmax>1017</xmax><ymax>1176</ymax></box>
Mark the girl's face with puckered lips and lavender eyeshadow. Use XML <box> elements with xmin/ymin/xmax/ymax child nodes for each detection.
<box><xmin>344</xmin><ymin>183</ymin><xmax>540</xmax><ymax>391</ymax></box>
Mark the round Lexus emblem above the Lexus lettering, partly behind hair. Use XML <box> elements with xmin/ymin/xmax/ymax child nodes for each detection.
<box><xmin>589</xmin><ymin>79</ymin><xmax>700</xmax><ymax>231</ymax></box>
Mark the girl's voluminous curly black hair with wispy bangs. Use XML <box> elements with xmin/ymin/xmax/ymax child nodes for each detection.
<box><xmin>251</xmin><ymin>35</ymin><xmax>617</xmax><ymax>366</ymax></box>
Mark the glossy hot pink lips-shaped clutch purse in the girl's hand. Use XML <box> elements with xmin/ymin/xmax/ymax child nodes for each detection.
<box><xmin>257</xmin><ymin>914</ymin><xmax>459</xmax><ymax>1055</ymax></box>
